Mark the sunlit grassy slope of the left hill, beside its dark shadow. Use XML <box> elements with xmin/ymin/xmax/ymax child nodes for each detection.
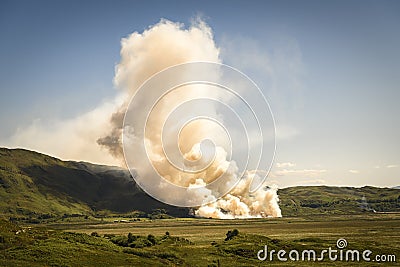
<box><xmin>0</xmin><ymin>148</ymin><xmax>90</xmax><ymax>218</ymax></box>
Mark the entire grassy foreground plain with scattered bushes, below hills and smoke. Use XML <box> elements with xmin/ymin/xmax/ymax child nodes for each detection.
<box><xmin>0</xmin><ymin>213</ymin><xmax>400</xmax><ymax>266</ymax></box>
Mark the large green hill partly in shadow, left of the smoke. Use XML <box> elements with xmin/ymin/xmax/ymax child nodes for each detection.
<box><xmin>0</xmin><ymin>148</ymin><xmax>188</xmax><ymax>219</ymax></box>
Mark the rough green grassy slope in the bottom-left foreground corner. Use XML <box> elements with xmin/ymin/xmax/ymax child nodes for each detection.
<box><xmin>0</xmin><ymin>219</ymin><xmax>158</xmax><ymax>266</ymax></box>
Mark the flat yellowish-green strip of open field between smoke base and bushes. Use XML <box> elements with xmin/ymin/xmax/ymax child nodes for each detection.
<box><xmin>52</xmin><ymin>213</ymin><xmax>400</xmax><ymax>246</ymax></box>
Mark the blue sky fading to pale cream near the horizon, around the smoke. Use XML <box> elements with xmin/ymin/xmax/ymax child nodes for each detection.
<box><xmin>0</xmin><ymin>1</ymin><xmax>400</xmax><ymax>186</ymax></box>
